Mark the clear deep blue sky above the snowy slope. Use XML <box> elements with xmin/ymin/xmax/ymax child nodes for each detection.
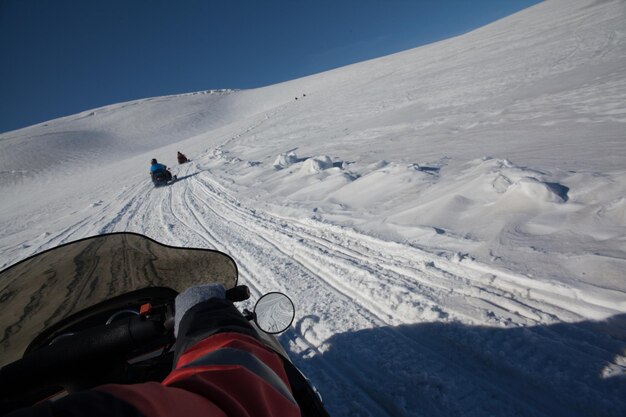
<box><xmin>0</xmin><ymin>0</ymin><xmax>539</xmax><ymax>132</ymax></box>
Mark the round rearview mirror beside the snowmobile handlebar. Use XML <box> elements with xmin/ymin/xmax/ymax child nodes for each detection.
<box><xmin>254</xmin><ymin>292</ymin><xmax>296</xmax><ymax>334</ymax></box>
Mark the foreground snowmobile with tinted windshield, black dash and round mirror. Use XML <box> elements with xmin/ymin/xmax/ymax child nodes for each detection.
<box><xmin>0</xmin><ymin>232</ymin><xmax>328</xmax><ymax>416</ymax></box>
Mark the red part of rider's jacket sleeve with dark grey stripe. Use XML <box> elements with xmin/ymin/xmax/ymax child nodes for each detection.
<box><xmin>98</xmin><ymin>333</ymin><xmax>300</xmax><ymax>417</ymax></box>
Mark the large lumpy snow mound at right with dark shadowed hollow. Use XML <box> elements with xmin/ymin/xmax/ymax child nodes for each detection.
<box><xmin>388</xmin><ymin>157</ymin><xmax>570</xmax><ymax>240</ymax></box>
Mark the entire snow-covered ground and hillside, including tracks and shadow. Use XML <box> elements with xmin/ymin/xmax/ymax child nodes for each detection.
<box><xmin>0</xmin><ymin>0</ymin><xmax>626</xmax><ymax>417</ymax></box>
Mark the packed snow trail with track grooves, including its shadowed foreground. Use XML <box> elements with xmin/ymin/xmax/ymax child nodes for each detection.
<box><xmin>73</xmin><ymin>163</ymin><xmax>626</xmax><ymax>416</ymax></box>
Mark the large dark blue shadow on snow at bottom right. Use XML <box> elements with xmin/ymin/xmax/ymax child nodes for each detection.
<box><xmin>282</xmin><ymin>314</ymin><xmax>626</xmax><ymax>417</ymax></box>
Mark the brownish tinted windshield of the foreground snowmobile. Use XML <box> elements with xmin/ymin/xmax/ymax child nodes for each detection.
<box><xmin>0</xmin><ymin>233</ymin><xmax>237</xmax><ymax>366</ymax></box>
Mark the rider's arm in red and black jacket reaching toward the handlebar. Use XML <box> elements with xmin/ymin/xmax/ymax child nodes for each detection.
<box><xmin>9</xmin><ymin>289</ymin><xmax>300</xmax><ymax>417</ymax></box>
